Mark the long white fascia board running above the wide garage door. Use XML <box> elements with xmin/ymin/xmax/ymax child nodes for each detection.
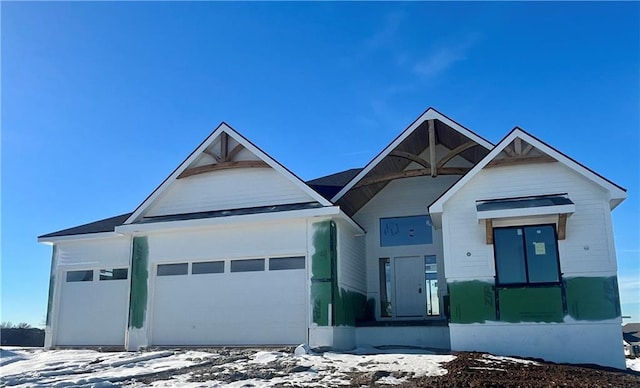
<box><xmin>116</xmin><ymin>206</ymin><xmax>340</xmax><ymax>234</ymax></box>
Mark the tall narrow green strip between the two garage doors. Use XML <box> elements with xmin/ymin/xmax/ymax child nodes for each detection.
<box><xmin>129</xmin><ymin>236</ymin><xmax>149</xmax><ymax>329</ymax></box>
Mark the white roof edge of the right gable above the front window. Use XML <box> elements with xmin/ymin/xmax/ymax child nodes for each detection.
<box><xmin>429</xmin><ymin>127</ymin><xmax>627</xmax><ymax>214</ymax></box>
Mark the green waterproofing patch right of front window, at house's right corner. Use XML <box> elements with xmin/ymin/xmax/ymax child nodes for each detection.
<box><xmin>565</xmin><ymin>276</ymin><xmax>621</xmax><ymax>321</ymax></box>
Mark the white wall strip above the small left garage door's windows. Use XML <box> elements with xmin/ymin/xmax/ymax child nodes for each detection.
<box><xmin>56</xmin><ymin>237</ymin><xmax>130</xmax><ymax>269</ymax></box>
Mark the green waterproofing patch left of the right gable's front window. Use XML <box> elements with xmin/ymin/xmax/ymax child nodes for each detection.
<box><xmin>447</xmin><ymin>280</ymin><xmax>496</xmax><ymax>323</ymax></box>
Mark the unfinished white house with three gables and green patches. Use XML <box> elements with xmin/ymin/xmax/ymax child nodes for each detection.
<box><xmin>38</xmin><ymin>108</ymin><xmax>626</xmax><ymax>368</ymax></box>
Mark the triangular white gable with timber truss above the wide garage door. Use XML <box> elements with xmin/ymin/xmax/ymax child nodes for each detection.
<box><xmin>125</xmin><ymin>123</ymin><xmax>331</xmax><ymax>224</ymax></box>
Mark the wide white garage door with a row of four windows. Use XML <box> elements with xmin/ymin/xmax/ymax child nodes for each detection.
<box><xmin>151</xmin><ymin>256</ymin><xmax>308</xmax><ymax>345</ymax></box>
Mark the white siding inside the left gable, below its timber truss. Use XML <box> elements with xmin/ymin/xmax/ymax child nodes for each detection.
<box><xmin>145</xmin><ymin>168</ymin><xmax>314</xmax><ymax>216</ymax></box>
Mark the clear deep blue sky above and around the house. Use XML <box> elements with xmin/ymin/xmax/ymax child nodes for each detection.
<box><xmin>0</xmin><ymin>2</ymin><xmax>640</xmax><ymax>326</ymax></box>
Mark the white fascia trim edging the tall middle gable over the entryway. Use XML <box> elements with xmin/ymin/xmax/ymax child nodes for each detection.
<box><xmin>331</xmin><ymin>108</ymin><xmax>493</xmax><ymax>203</ymax></box>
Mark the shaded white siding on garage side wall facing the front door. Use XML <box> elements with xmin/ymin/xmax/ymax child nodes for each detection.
<box><xmin>338</xmin><ymin>222</ymin><xmax>366</xmax><ymax>293</ymax></box>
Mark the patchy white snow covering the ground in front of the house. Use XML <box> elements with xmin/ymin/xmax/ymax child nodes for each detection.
<box><xmin>0</xmin><ymin>347</ymin><xmax>580</xmax><ymax>388</ymax></box>
